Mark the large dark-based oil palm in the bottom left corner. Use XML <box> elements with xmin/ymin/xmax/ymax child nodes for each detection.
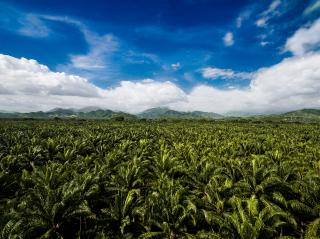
<box><xmin>3</xmin><ymin>163</ymin><xmax>96</xmax><ymax>238</ymax></box>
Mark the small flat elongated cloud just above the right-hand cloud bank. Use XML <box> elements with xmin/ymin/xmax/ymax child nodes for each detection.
<box><xmin>201</xmin><ymin>67</ymin><xmax>254</xmax><ymax>79</ymax></box>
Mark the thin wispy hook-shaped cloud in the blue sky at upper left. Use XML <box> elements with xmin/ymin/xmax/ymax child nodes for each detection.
<box><xmin>0</xmin><ymin>8</ymin><xmax>119</xmax><ymax>74</ymax></box>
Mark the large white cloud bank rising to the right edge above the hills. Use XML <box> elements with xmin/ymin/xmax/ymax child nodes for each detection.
<box><xmin>175</xmin><ymin>53</ymin><xmax>320</xmax><ymax>113</ymax></box>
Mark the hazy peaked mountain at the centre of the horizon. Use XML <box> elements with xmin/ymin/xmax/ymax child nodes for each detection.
<box><xmin>137</xmin><ymin>107</ymin><xmax>223</xmax><ymax>119</ymax></box>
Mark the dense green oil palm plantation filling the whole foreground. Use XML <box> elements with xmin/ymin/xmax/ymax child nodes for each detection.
<box><xmin>0</xmin><ymin>120</ymin><xmax>320</xmax><ymax>239</ymax></box>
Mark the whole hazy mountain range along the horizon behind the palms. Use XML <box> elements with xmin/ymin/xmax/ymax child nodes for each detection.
<box><xmin>0</xmin><ymin>107</ymin><xmax>320</xmax><ymax>120</ymax></box>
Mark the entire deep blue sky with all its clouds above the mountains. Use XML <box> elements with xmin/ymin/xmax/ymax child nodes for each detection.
<box><xmin>0</xmin><ymin>0</ymin><xmax>320</xmax><ymax>114</ymax></box>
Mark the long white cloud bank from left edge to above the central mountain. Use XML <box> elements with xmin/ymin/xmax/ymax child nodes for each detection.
<box><xmin>0</xmin><ymin>54</ymin><xmax>186</xmax><ymax>112</ymax></box>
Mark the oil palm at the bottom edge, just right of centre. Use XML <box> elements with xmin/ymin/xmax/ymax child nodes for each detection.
<box><xmin>139</xmin><ymin>175</ymin><xmax>197</xmax><ymax>239</ymax></box>
